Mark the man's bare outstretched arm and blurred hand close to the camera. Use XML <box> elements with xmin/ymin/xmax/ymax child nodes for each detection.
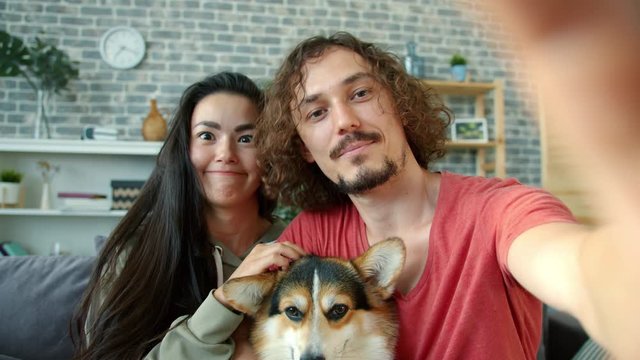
<box><xmin>492</xmin><ymin>0</ymin><xmax>640</xmax><ymax>359</ymax></box>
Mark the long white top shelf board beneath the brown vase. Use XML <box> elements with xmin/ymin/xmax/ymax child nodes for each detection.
<box><xmin>0</xmin><ymin>139</ymin><xmax>162</xmax><ymax>156</ymax></box>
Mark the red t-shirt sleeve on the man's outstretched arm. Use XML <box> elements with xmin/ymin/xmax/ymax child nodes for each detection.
<box><xmin>488</xmin><ymin>184</ymin><xmax>576</xmax><ymax>278</ymax></box>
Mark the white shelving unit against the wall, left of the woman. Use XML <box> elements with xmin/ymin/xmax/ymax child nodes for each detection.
<box><xmin>0</xmin><ymin>139</ymin><xmax>162</xmax><ymax>255</ymax></box>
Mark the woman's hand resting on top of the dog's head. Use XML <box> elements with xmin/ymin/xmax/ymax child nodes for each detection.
<box><xmin>213</xmin><ymin>241</ymin><xmax>306</xmax><ymax>310</ymax></box>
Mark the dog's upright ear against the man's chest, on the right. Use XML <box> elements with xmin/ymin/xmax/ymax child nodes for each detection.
<box><xmin>353</xmin><ymin>237</ymin><xmax>406</xmax><ymax>299</ymax></box>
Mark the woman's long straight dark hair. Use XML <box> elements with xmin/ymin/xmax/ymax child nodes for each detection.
<box><xmin>71</xmin><ymin>72</ymin><xmax>275</xmax><ymax>360</ymax></box>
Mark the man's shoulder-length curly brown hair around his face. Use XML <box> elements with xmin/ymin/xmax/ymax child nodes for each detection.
<box><xmin>255</xmin><ymin>32</ymin><xmax>452</xmax><ymax>210</ymax></box>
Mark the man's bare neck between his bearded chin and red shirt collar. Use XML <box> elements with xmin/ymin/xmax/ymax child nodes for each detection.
<box><xmin>350</xmin><ymin>163</ymin><xmax>440</xmax><ymax>244</ymax></box>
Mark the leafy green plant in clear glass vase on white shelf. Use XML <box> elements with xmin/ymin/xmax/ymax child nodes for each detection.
<box><xmin>0</xmin><ymin>31</ymin><xmax>79</xmax><ymax>138</ymax></box>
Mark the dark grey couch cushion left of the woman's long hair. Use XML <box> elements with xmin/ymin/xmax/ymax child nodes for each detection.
<box><xmin>0</xmin><ymin>256</ymin><xmax>95</xmax><ymax>360</ymax></box>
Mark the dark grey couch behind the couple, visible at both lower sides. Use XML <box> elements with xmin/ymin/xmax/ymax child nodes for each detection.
<box><xmin>0</xmin><ymin>253</ymin><xmax>607</xmax><ymax>360</ymax></box>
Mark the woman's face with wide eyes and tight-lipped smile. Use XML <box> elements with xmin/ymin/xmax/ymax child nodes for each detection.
<box><xmin>189</xmin><ymin>92</ymin><xmax>261</xmax><ymax>208</ymax></box>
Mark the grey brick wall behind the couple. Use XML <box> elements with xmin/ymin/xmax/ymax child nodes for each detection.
<box><xmin>0</xmin><ymin>0</ymin><xmax>540</xmax><ymax>185</ymax></box>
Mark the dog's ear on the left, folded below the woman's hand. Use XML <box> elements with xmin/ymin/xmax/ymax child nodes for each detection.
<box><xmin>222</xmin><ymin>272</ymin><xmax>277</xmax><ymax>317</ymax></box>
